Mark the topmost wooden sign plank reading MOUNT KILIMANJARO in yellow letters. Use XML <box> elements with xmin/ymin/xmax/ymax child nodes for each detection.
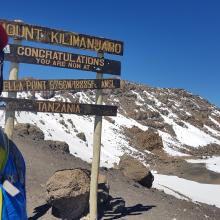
<box><xmin>0</xmin><ymin>19</ymin><xmax>123</xmax><ymax>55</ymax></box>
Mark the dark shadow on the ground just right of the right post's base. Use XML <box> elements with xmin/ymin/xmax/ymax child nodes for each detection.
<box><xmin>99</xmin><ymin>198</ymin><xmax>156</xmax><ymax>220</ymax></box>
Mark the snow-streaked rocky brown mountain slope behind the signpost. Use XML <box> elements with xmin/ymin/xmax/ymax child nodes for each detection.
<box><xmin>1</xmin><ymin>81</ymin><xmax>220</xmax><ymax>163</ymax></box>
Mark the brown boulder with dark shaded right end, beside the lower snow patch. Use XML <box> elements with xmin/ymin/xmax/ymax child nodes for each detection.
<box><xmin>119</xmin><ymin>154</ymin><xmax>154</xmax><ymax>188</ymax></box>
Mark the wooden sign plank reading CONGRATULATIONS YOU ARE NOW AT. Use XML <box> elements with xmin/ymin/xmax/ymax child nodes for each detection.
<box><xmin>5</xmin><ymin>44</ymin><xmax>121</xmax><ymax>75</ymax></box>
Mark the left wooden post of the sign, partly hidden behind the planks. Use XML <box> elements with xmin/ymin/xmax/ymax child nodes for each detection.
<box><xmin>5</xmin><ymin>20</ymin><xmax>22</xmax><ymax>140</ymax></box>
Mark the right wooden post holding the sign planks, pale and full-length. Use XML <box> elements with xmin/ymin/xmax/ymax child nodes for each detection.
<box><xmin>89</xmin><ymin>53</ymin><xmax>104</xmax><ymax>220</ymax></box>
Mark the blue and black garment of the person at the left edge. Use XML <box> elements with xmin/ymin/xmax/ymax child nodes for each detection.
<box><xmin>0</xmin><ymin>130</ymin><xmax>27</xmax><ymax>220</ymax></box>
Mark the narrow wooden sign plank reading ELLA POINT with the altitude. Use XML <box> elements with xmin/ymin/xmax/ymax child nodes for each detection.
<box><xmin>3</xmin><ymin>79</ymin><xmax>120</xmax><ymax>92</ymax></box>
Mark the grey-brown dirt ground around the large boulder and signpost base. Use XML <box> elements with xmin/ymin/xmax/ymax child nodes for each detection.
<box><xmin>14</xmin><ymin>134</ymin><xmax>220</xmax><ymax>220</ymax></box>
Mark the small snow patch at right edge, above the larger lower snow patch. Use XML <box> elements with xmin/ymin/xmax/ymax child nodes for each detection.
<box><xmin>186</xmin><ymin>156</ymin><xmax>220</xmax><ymax>173</ymax></box>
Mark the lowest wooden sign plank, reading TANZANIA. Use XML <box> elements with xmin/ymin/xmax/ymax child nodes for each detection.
<box><xmin>0</xmin><ymin>97</ymin><xmax>117</xmax><ymax>116</ymax></box>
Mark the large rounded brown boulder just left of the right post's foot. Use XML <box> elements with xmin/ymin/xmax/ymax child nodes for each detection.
<box><xmin>46</xmin><ymin>169</ymin><xmax>90</xmax><ymax>220</ymax></box>
